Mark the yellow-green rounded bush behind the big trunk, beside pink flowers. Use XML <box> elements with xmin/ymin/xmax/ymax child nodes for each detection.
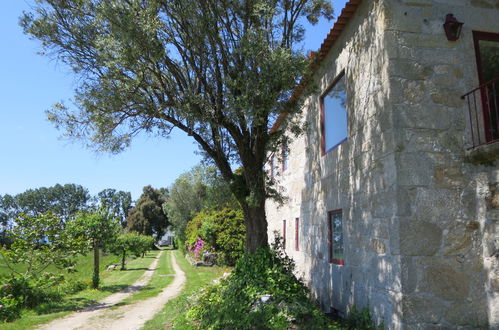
<box><xmin>186</xmin><ymin>208</ymin><xmax>246</xmax><ymax>265</ymax></box>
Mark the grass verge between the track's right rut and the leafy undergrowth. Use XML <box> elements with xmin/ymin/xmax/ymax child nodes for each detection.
<box><xmin>143</xmin><ymin>250</ymin><xmax>227</xmax><ymax>330</ymax></box>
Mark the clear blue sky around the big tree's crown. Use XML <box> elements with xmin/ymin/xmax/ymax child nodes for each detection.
<box><xmin>0</xmin><ymin>0</ymin><xmax>346</xmax><ymax>199</ymax></box>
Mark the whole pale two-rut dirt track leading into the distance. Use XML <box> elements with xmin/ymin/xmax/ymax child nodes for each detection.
<box><xmin>40</xmin><ymin>251</ymin><xmax>185</xmax><ymax>330</ymax></box>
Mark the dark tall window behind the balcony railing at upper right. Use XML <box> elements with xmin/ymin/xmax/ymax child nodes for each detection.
<box><xmin>473</xmin><ymin>31</ymin><xmax>499</xmax><ymax>142</ymax></box>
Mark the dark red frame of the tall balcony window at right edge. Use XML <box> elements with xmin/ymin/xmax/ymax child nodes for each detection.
<box><xmin>473</xmin><ymin>31</ymin><xmax>499</xmax><ymax>142</ymax></box>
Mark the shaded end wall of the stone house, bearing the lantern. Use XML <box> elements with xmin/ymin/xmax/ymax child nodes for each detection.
<box><xmin>384</xmin><ymin>0</ymin><xmax>499</xmax><ymax>328</ymax></box>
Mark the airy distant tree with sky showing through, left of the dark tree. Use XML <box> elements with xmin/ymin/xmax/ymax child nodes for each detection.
<box><xmin>97</xmin><ymin>189</ymin><xmax>132</xmax><ymax>227</ymax></box>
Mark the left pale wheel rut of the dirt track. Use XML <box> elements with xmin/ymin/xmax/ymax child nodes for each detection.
<box><xmin>38</xmin><ymin>251</ymin><xmax>164</xmax><ymax>330</ymax></box>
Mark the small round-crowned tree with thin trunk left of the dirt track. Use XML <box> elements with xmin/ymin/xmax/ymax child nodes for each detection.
<box><xmin>67</xmin><ymin>211</ymin><xmax>120</xmax><ymax>289</ymax></box>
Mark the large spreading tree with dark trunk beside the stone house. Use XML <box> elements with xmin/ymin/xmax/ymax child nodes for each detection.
<box><xmin>21</xmin><ymin>0</ymin><xmax>332</xmax><ymax>251</ymax></box>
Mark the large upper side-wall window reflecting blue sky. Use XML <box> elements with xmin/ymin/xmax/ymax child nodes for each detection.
<box><xmin>321</xmin><ymin>73</ymin><xmax>348</xmax><ymax>155</ymax></box>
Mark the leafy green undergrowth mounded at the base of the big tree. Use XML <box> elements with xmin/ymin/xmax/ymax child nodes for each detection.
<box><xmin>189</xmin><ymin>238</ymin><xmax>328</xmax><ymax>329</ymax></box>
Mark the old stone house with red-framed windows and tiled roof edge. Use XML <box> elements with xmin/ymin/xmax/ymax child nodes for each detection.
<box><xmin>266</xmin><ymin>0</ymin><xmax>499</xmax><ymax>329</ymax></box>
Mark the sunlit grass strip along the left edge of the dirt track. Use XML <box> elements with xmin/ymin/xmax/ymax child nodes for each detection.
<box><xmin>0</xmin><ymin>251</ymin><xmax>158</xmax><ymax>330</ymax></box>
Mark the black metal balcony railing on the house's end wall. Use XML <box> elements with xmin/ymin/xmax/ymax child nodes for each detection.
<box><xmin>461</xmin><ymin>77</ymin><xmax>499</xmax><ymax>149</ymax></box>
